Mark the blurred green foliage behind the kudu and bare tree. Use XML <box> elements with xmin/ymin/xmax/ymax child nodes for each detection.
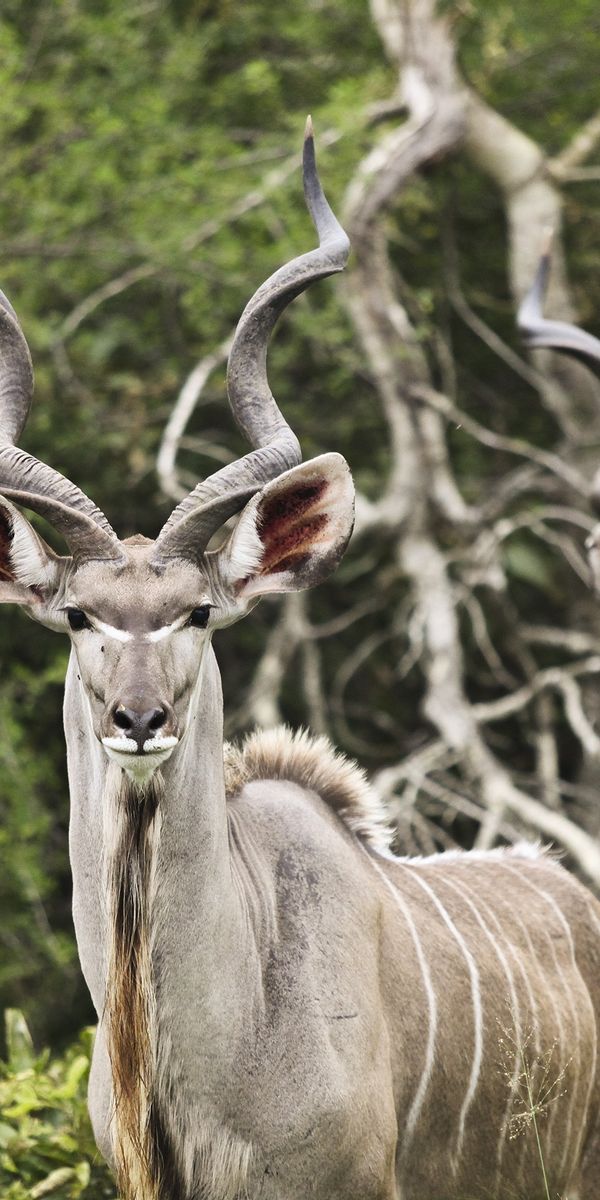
<box><xmin>0</xmin><ymin>0</ymin><xmax>600</xmax><ymax>1196</ymax></box>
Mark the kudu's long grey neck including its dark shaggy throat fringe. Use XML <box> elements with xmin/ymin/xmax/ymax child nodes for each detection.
<box><xmin>65</xmin><ymin>647</ymin><xmax>256</xmax><ymax>1200</ymax></box>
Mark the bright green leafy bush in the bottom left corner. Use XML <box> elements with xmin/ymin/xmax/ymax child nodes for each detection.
<box><xmin>0</xmin><ymin>1008</ymin><xmax>115</xmax><ymax>1200</ymax></box>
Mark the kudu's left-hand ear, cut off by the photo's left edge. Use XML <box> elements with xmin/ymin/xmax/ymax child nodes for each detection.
<box><xmin>0</xmin><ymin>496</ymin><xmax>68</xmax><ymax>625</ymax></box>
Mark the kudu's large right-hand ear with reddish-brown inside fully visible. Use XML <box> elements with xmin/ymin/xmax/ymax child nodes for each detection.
<box><xmin>215</xmin><ymin>454</ymin><xmax>354</xmax><ymax>600</ymax></box>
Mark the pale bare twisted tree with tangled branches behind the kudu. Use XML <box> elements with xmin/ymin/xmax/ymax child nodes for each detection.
<box><xmin>153</xmin><ymin>0</ymin><xmax>600</xmax><ymax>886</ymax></box>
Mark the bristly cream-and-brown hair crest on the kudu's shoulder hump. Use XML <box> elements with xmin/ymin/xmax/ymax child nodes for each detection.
<box><xmin>223</xmin><ymin>725</ymin><xmax>392</xmax><ymax>853</ymax></box>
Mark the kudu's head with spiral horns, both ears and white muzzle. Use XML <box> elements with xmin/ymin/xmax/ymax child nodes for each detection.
<box><xmin>0</xmin><ymin>124</ymin><xmax>354</xmax><ymax>784</ymax></box>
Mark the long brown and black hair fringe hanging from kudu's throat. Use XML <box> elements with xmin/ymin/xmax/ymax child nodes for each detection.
<box><xmin>104</xmin><ymin>775</ymin><xmax>180</xmax><ymax>1200</ymax></box>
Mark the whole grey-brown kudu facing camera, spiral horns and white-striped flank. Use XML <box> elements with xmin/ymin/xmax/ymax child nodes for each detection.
<box><xmin>0</xmin><ymin>126</ymin><xmax>600</xmax><ymax>1200</ymax></box>
